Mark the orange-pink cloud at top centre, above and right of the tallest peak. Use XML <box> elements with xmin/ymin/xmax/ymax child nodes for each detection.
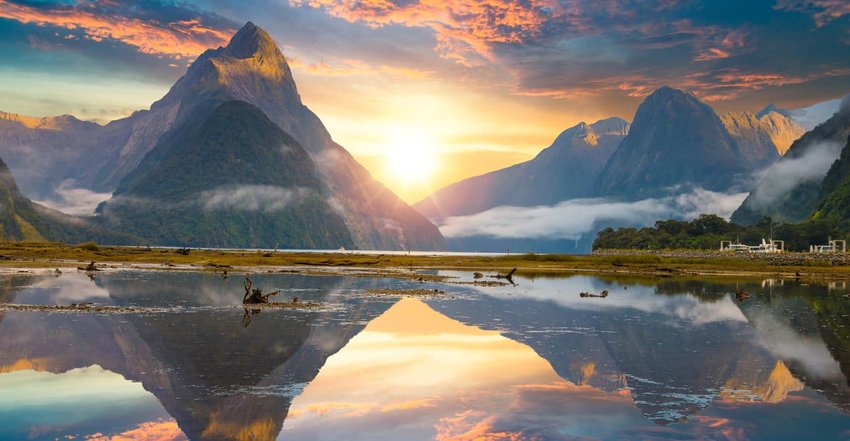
<box><xmin>290</xmin><ymin>0</ymin><xmax>567</xmax><ymax>65</ymax></box>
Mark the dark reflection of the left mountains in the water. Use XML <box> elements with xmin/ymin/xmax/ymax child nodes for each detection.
<box><xmin>0</xmin><ymin>273</ymin><xmax>390</xmax><ymax>440</ymax></box>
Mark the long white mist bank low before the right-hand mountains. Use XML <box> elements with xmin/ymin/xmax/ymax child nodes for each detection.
<box><xmin>440</xmin><ymin>188</ymin><xmax>746</xmax><ymax>240</ymax></box>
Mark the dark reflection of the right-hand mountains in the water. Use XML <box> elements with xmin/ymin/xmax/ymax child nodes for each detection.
<box><xmin>434</xmin><ymin>276</ymin><xmax>850</xmax><ymax>425</ymax></box>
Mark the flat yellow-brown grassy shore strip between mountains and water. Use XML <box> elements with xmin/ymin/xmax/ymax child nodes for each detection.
<box><xmin>0</xmin><ymin>242</ymin><xmax>850</xmax><ymax>279</ymax></box>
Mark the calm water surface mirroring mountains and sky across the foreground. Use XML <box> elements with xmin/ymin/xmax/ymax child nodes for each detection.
<box><xmin>0</xmin><ymin>271</ymin><xmax>850</xmax><ymax>440</ymax></box>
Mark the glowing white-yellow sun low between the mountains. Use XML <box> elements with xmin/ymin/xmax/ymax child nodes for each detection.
<box><xmin>385</xmin><ymin>132</ymin><xmax>437</xmax><ymax>185</ymax></box>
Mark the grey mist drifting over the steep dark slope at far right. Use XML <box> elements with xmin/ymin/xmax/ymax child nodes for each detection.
<box><xmin>750</xmin><ymin>142</ymin><xmax>841</xmax><ymax>208</ymax></box>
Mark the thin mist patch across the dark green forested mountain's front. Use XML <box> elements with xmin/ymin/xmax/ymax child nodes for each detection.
<box><xmin>201</xmin><ymin>185</ymin><xmax>313</xmax><ymax>213</ymax></box>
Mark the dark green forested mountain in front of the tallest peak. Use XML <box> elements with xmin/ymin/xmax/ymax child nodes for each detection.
<box><xmin>98</xmin><ymin>101</ymin><xmax>353</xmax><ymax>249</ymax></box>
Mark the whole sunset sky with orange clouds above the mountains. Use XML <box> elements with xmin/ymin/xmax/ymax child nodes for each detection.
<box><xmin>0</xmin><ymin>0</ymin><xmax>850</xmax><ymax>202</ymax></box>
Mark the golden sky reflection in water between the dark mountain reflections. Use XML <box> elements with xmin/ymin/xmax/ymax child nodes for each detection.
<box><xmin>282</xmin><ymin>298</ymin><xmax>649</xmax><ymax>440</ymax></box>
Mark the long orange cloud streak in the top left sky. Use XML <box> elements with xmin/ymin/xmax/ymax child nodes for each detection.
<box><xmin>0</xmin><ymin>0</ymin><xmax>233</xmax><ymax>58</ymax></box>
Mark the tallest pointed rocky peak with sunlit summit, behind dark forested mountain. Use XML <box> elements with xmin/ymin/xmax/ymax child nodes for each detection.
<box><xmin>0</xmin><ymin>23</ymin><xmax>445</xmax><ymax>250</ymax></box>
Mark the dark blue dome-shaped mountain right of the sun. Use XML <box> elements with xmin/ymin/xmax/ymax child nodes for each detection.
<box><xmin>597</xmin><ymin>87</ymin><xmax>764</xmax><ymax>199</ymax></box>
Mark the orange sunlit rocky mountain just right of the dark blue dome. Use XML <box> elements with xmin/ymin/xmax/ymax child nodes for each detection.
<box><xmin>720</xmin><ymin>110</ymin><xmax>806</xmax><ymax>159</ymax></box>
